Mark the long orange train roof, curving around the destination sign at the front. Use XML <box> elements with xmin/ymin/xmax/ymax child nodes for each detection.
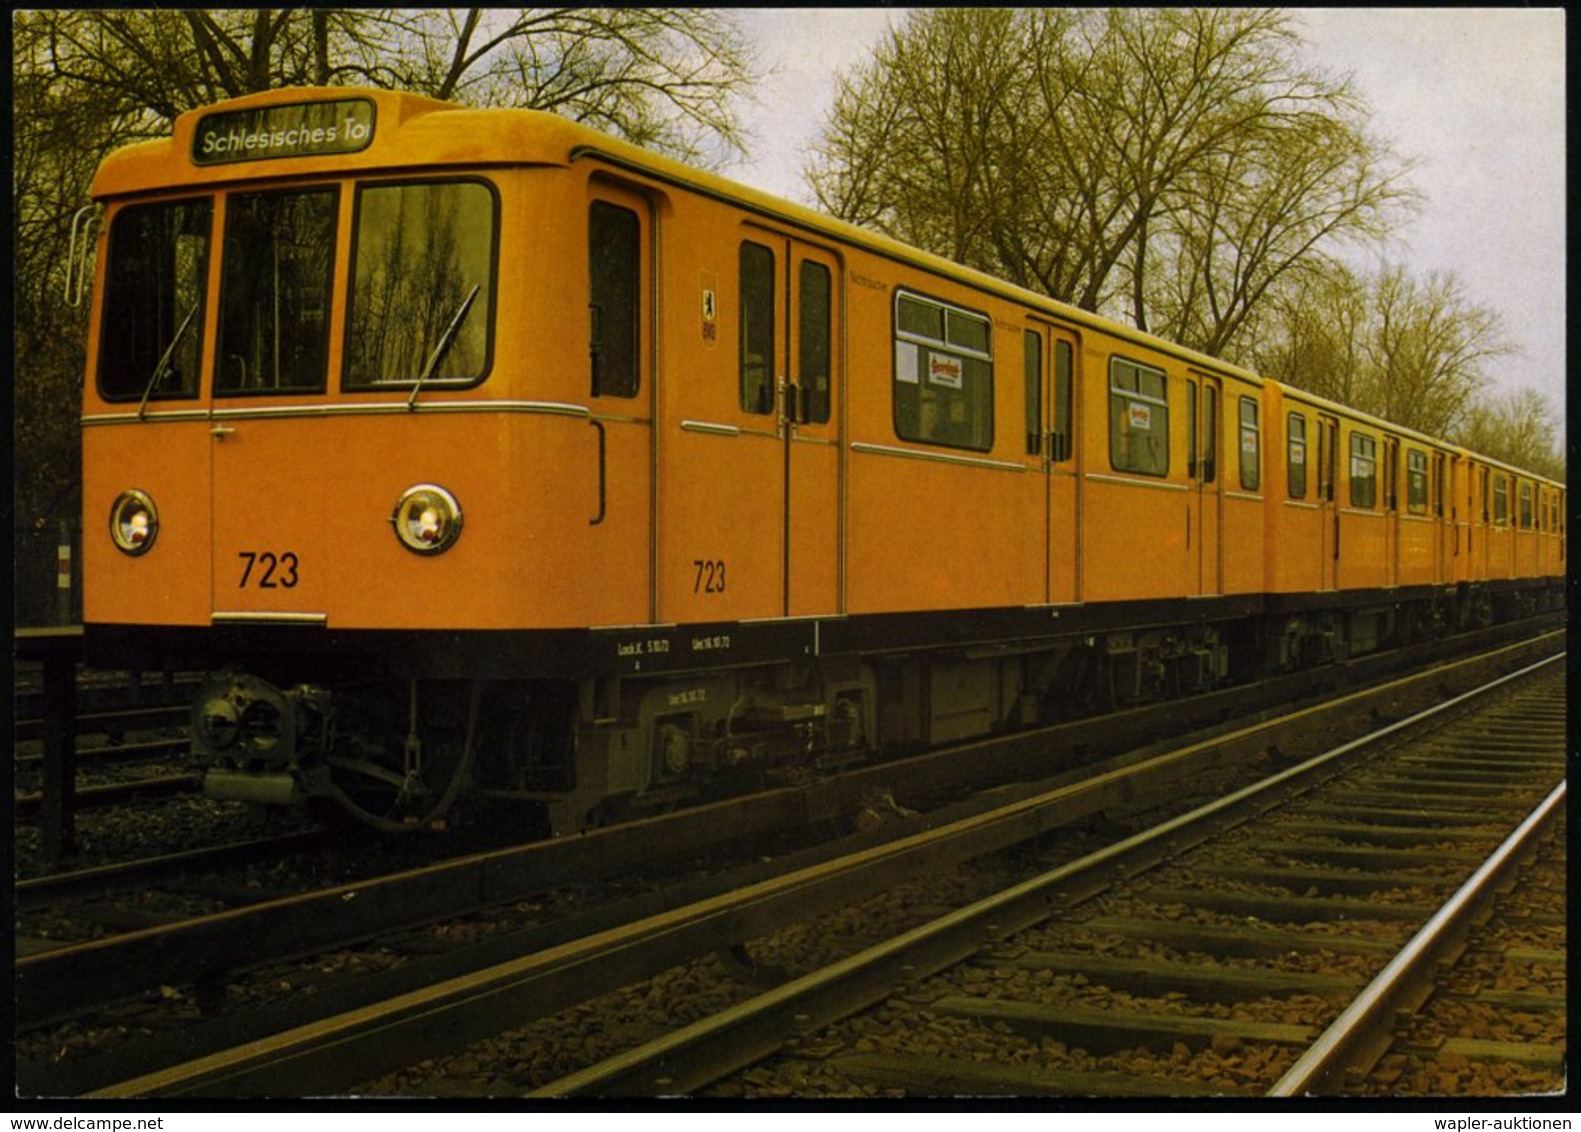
<box><xmin>92</xmin><ymin>87</ymin><xmax>1564</xmax><ymax>487</ymax></box>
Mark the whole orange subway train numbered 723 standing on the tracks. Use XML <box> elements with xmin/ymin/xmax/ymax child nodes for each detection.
<box><xmin>81</xmin><ymin>89</ymin><xmax>1565</xmax><ymax>833</ymax></box>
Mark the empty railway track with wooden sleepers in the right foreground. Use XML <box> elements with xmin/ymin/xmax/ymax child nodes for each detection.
<box><xmin>534</xmin><ymin>664</ymin><xmax>1565</xmax><ymax>1097</ymax></box>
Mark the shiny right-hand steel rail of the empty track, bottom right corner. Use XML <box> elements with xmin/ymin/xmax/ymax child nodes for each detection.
<box><xmin>1268</xmin><ymin>783</ymin><xmax>1565</xmax><ymax>1097</ymax></box>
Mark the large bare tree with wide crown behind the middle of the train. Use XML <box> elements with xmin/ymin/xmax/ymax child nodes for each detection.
<box><xmin>808</xmin><ymin>8</ymin><xmax>1413</xmax><ymax>353</ymax></box>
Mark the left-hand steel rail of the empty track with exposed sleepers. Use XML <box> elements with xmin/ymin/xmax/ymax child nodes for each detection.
<box><xmin>528</xmin><ymin>653</ymin><xmax>1564</xmax><ymax>1099</ymax></box>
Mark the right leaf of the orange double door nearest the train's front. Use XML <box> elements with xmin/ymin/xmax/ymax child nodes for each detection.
<box><xmin>776</xmin><ymin>239</ymin><xmax>844</xmax><ymax>617</ymax></box>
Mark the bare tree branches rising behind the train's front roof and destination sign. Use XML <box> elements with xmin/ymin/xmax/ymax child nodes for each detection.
<box><xmin>25</xmin><ymin>8</ymin><xmax>754</xmax><ymax>160</ymax></box>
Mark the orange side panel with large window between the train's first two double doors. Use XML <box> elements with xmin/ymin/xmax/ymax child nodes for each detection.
<box><xmin>846</xmin><ymin>251</ymin><xmax>1048</xmax><ymax>613</ymax></box>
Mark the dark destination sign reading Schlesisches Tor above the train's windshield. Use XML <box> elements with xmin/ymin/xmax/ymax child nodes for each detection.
<box><xmin>193</xmin><ymin>98</ymin><xmax>373</xmax><ymax>164</ymax></box>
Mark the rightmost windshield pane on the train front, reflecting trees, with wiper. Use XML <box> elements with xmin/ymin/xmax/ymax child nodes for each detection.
<box><xmin>345</xmin><ymin>180</ymin><xmax>496</xmax><ymax>387</ymax></box>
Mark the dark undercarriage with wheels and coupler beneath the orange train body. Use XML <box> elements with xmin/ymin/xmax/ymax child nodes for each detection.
<box><xmin>169</xmin><ymin>583</ymin><xmax>1562</xmax><ymax>835</ymax></box>
